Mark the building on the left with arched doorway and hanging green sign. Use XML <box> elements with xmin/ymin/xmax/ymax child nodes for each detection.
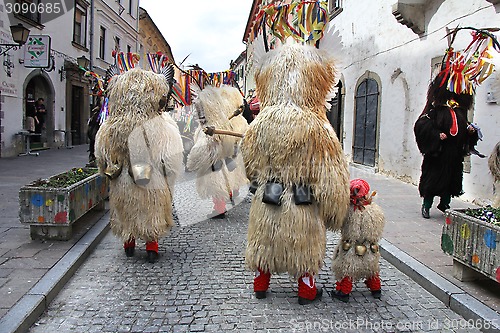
<box><xmin>0</xmin><ymin>0</ymin><xmax>139</xmax><ymax>157</ymax></box>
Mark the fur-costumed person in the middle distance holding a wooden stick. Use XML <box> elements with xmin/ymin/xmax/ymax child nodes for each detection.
<box><xmin>187</xmin><ymin>85</ymin><xmax>248</xmax><ymax>218</ymax></box>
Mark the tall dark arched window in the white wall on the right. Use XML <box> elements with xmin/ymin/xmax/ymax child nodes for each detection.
<box><xmin>352</xmin><ymin>79</ymin><xmax>379</xmax><ymax>167</ymax></box>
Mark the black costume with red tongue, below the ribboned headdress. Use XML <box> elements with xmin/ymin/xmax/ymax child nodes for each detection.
<box><xmin>414</xmin><ymin>71</ymin><xmax>478</xmax><ymax>218</ymax></box>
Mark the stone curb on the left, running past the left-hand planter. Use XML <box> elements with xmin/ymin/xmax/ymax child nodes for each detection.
<box><xmin>0</xmin><ymin>213</ymin><xmax>109</xmax><ymax>333</ymax></box>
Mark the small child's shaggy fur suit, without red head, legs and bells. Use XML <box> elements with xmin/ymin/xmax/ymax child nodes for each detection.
<box><xmin>332</xmin><ymin>197</ymin><xmax>385</xmax><ymax>282</ymax></box>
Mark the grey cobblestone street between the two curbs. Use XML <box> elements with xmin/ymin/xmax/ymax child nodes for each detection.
<box><xmin>29</xmin><ymin>188</ymin><xmax>487</xmax><ymax>333</ymax></box>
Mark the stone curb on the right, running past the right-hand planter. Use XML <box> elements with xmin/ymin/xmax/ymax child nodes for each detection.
<box><xmin>379</xmin><ymin>238</ymin><xmax>500</xmax><ymax>333</ymax></box>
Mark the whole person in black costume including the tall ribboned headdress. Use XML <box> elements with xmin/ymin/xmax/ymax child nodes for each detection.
<box><xmin>414</xmin><ymin>27</ymin><xmax>500</xmax><ymax>218</ymax></box>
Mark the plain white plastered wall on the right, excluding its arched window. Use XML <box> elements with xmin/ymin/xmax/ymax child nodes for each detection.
<box><xmin>333</xmin><ymin>0</ymin><xmax>500</xmax><ymax>203</ymax></box>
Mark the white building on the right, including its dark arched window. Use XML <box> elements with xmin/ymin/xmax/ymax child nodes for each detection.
<box><xmin>244</xmin><ymin>0</ymin><xmax>500</xmax><ymax>204</ymax></box>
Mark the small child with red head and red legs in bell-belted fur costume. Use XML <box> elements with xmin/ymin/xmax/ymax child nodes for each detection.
<box><xmin>332</xmin><ymin>179</ymin><xmax>385</xmax><ymax>302</ymax></box>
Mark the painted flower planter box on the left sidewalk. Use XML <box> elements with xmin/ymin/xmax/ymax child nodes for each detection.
<box><xmin>19</xmin><ymin>173</ymin><xmax>109</xmax><ymax>240</ymax></box>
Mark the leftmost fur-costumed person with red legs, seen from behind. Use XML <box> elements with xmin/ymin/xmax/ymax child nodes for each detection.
<box><xmin>96</xmin><ymin>68</ymin><xmax>183</xmax><ymax>262</ymax></box>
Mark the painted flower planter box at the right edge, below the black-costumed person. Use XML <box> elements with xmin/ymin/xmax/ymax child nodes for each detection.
<box><xmin>441</xmin><ymin>210</ymin><xmax>500</xmax><ymax>283</ymax></box>
